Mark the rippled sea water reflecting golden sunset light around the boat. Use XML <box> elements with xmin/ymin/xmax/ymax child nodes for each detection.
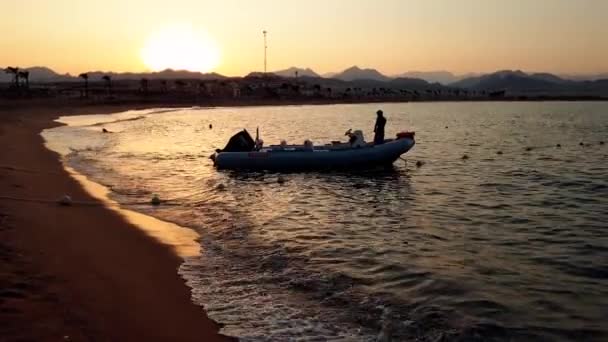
<box><xmin>43</xmin><ymin>102</ymin><xmax>608</xmax><ymax>341</ymax></box>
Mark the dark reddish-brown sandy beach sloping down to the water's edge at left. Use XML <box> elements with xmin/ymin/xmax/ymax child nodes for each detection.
<box><xmin>0</xmin><ymin>101</ymin><xmax>234</xmax><ymax>341</ymax></box>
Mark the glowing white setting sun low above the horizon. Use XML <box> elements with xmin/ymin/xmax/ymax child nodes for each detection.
<box><xmin>141</xmin><ymin>26</ymin><xmax>220</xmax><ymax>72</ymax></box>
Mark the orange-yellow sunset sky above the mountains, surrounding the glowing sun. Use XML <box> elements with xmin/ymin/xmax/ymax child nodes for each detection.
<box><xmin>0</xmin><ymin>0</ymin><xmax>608</xmax><ymax>75</ymax></box>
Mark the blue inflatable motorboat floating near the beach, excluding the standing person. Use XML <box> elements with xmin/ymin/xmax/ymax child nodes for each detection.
<box><xmin>211</xmin><ymin>130</ymin><xmax>416</xmax><ymax>171</ymax></box>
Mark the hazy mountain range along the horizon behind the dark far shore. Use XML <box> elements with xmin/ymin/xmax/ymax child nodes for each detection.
<box><xmin>0</xmin><ymin>66</ymin><xmax>608</xmax><ymax>96</ymax></box>
